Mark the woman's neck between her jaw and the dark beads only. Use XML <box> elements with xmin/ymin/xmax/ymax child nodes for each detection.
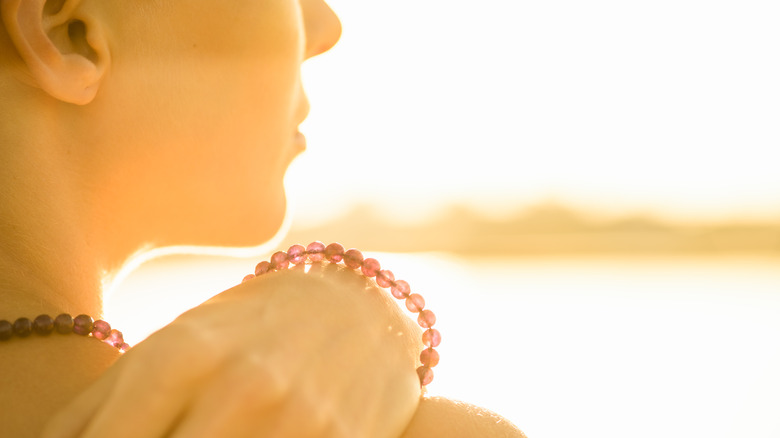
<box><xmin>0</xmin><ymin>118</ymin><xmax>111</xmax><ymax>320</ymax></box>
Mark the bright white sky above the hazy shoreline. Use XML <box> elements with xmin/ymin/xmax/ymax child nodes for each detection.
<box><xmin>288</xmin><ymin>0</ymin><xmax>780</xmax><ymax>223</ymax></box>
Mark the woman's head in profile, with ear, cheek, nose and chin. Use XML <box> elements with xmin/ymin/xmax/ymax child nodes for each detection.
<box><xmin>0</xmin><ymin>0</ymin><xmax>340</xmax><ymax>262</ymax></box>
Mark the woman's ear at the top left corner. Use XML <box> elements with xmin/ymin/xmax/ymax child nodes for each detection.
<box><xmin>0</xmin><ymin>0</ymin><xmax>110</xmax><ymax>105</ymax></box>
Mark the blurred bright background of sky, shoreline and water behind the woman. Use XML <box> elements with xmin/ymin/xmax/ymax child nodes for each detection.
<box><xmin>107</xmin><ymin>0</ymin><xmax>780</xmax><ymax>438</ymax></box>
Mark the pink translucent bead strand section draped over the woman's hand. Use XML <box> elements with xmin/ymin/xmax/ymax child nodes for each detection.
<box><xmin>243</xmin><ymin>242</ymin><xmax>441</xmax><ymax>386</ymax></box>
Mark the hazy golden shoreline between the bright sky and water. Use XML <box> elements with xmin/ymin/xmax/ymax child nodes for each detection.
<box><xmin>283</xmin><ymin>203</ymin><xmax>780</xmax><ymax>256</ymax></box>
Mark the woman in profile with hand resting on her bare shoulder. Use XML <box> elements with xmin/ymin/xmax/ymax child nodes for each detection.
<box><xmin>0</xmin><ymin>0</ymin><xmax>522</xmax><ymax>438</ymax></box>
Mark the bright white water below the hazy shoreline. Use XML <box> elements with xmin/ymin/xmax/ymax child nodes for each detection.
<box><xmin>109</xmin><ymin>254</ymin><xmax>780</xmax><ymax>438</ymax></box>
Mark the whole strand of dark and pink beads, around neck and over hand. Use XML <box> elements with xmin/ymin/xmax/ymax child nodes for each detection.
<box><xmin>0</xmin><ymin>242</ymin><xmax>441</xmax><ymax>386</ymax></box>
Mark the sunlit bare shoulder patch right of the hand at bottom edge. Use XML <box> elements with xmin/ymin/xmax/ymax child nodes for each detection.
<box><xmin>402</xmin><ymin>397</ymin><xmax>526</xmax><ymax>438</ymax></box>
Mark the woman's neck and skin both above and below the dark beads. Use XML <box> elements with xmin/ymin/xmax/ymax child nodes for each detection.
<box><xmin>0</xmin><ymin>116</ymin><xmax>123</xmax><ymax>438</ymax></box>
